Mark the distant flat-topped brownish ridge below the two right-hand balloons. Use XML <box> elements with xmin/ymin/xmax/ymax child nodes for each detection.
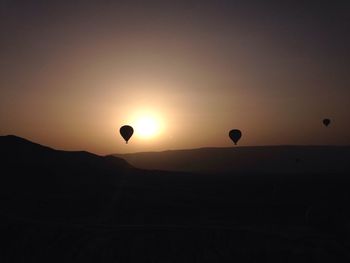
<box><xmin>114</xmin><ymin>146</ymin><xmax>350</xmax><ymax>175</ymax></box>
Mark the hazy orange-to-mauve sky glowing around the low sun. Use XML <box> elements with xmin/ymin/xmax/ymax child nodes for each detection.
<box><xmin>0</xmin><ymin>0</ymin><xmax>350</xmax><ymax>154</ymax></box>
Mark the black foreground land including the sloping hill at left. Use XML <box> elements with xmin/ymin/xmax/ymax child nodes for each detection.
<box><xmin>0</xmin><ymin>136</ymin><xmax>350</xmax><ymax>263</ymax></box>
